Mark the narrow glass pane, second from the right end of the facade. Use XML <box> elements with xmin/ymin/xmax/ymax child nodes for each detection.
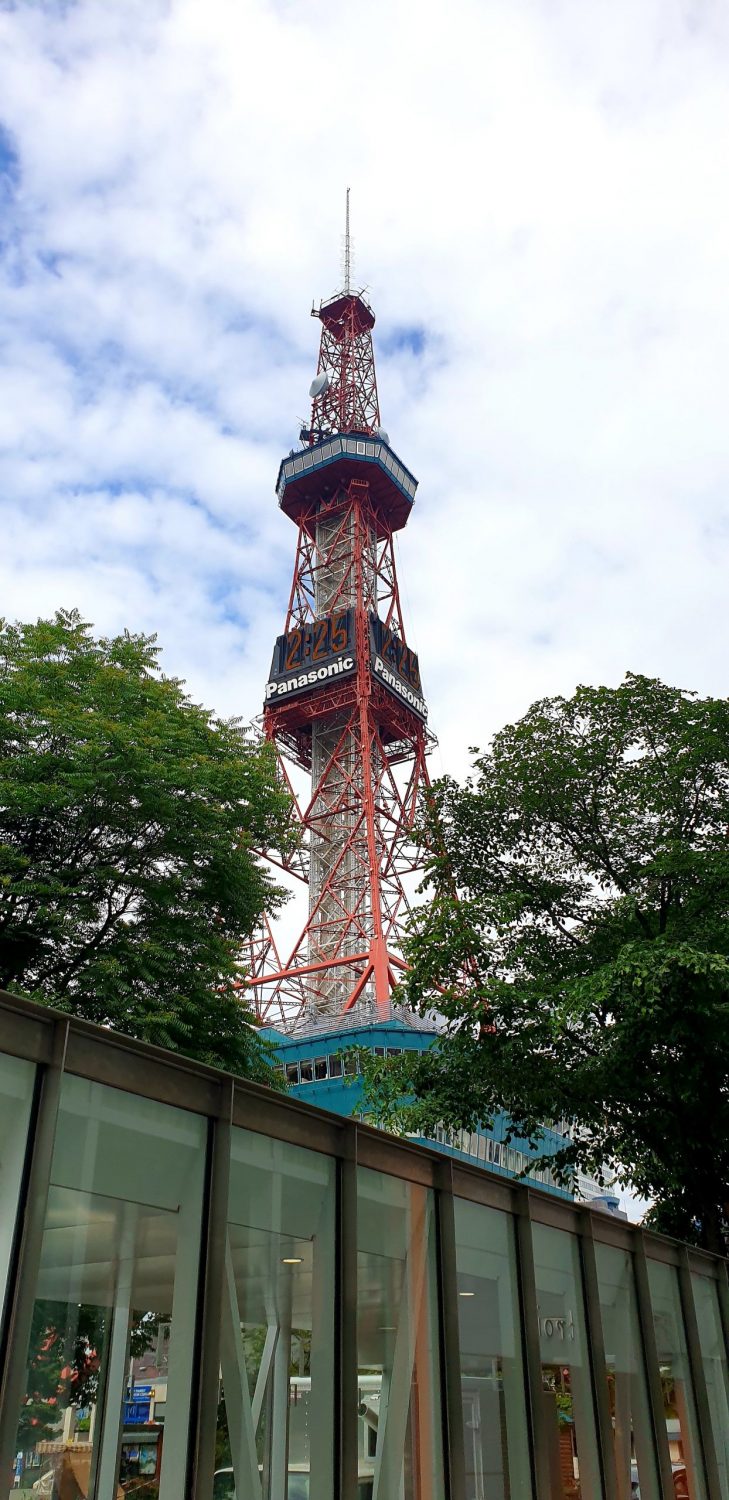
<box><xmin>648</xmin><ymin>1260</ymin><xmax>707</xmax><ymax>1500</ymax></box>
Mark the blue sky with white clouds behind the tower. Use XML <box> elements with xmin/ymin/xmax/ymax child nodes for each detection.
<box><xmin>0</xmin><ymin>0</ymin><xmax>729</xmax><ymax>773</ymax></box>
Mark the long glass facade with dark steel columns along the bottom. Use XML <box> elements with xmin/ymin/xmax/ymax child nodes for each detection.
<box><xmin>0</xmin><ymin>996</ymin><xmax>729</xmax><ymax>1500</ymax></box>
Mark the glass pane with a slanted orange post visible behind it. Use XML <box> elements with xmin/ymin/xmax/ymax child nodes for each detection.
<box><xmin>357</xmin><ymin>1167</ymin><xmax>444</xmax><ymax>1500</ymax></box>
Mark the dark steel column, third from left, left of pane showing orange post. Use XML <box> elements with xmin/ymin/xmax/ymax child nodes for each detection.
<box><xmin>335</xmin><ymin>1124</ymin><xmax>359</xmax><ymax>1500</ymax></box>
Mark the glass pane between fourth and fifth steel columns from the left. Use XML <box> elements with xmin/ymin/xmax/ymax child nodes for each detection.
<box><xmin>455</xmin><ymin>1199</ymin><xmax>531</xmax><ymax>1500</ymax></box>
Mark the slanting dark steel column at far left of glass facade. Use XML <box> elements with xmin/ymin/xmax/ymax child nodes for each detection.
<box><xmin>0</xmin><ymin>1020</ymin><xmax>69</xmax><ymax>1475</ymax></box>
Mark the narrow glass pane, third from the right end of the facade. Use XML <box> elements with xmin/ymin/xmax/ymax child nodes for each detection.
<box><xmin>596</xmin><ymin>1245</ymin><xmax>660</xmax><ymax>1500</ymax></box>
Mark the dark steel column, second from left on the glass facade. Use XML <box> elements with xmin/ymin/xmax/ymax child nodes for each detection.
<box><xmin>191</xmin><ymin>1079</ymin><xmax>234</xmax><ymax>1500</ymax></box>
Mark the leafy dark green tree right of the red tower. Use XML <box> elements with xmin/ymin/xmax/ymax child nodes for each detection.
<box><xmin>368</xmin><ymin>675</ymin><xmax>729</xmax><ymax>1250</ymax></box>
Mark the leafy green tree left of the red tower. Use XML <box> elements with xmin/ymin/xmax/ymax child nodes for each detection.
<box><xmin>0</xmin><ymin>612</ymin><xmax>290</xmax><ymax>1082</ymax></box>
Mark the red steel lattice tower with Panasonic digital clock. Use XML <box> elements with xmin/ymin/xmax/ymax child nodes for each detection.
<box><xmin>249</xmin><ymin>219</ymin><xmax>434</xmax><ymax>1032</ymax></box>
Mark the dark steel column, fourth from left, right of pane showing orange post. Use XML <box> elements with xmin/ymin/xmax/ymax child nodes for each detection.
<box><xmin>435</xmin><ymin>1157</ymin><xmax>465</xmax><ymax>1500</ymax></box>
